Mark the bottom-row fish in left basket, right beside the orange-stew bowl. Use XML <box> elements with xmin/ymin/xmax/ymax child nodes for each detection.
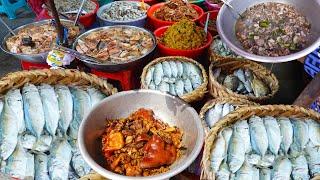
<box><xmin>71</xmin><ymin>150</ymin><xmax>91</xmax><ymax>177</ymax></box>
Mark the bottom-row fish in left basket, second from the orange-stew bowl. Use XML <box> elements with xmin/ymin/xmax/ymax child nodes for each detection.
<box><xmin>48</xmin><ymin>139</ymin><xmax>72</xmax><ymax>180</ymax></box>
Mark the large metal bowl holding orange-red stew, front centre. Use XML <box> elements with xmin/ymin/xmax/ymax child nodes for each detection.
<box><xmin>78</xmin><ymin>90</ymin><xmax>204</xmax><ymax>180</ymax></box>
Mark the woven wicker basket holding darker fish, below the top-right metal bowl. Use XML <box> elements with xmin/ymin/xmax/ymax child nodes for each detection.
<box><xmin>209</xmin><ymin>58</ymin><xmax>279</xmax><ymax>103</ymax></box>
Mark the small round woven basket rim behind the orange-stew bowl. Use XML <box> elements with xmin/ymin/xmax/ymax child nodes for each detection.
<box><xmin>141</xmin><ymin>56</ymin><xmax>208</xmax><ymax>103</ymax></box>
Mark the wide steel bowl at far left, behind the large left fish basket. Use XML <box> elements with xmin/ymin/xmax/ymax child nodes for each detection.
<box><xmin>1</xmin><ymin>19</ymin><xmax>84</xmax><ymax>63</ymax></box>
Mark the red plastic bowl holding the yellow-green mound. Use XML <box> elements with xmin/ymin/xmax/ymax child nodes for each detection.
<box><xmin>154</xmin><ymin>26</ymin><xmax>212</xmax><ymax>58</ymax></box>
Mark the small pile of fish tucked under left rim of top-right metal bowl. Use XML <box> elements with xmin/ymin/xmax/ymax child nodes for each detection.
<box><xmin>210</xmin><ymin>37</ymin><xmax>243</xmax><ymax>58</ymax></box>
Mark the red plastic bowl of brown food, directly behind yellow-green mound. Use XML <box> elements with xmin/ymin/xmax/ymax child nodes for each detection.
<box><xmin>147</xmin><ymin>3</ymin><xmax>204</xmax><ymax>29</ymax></box>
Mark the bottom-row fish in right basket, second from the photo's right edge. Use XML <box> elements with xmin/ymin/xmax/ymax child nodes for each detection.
<box><xmin>291</xmin><ymin>155</ymin><xmax>310</xmax><ymax>180</ymax></box>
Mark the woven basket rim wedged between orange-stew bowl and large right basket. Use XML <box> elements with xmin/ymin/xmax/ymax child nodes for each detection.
<box><xmin>199</xmin><ymin>97</ymin><xmax>258</xmax><ymax>135</ymax></box>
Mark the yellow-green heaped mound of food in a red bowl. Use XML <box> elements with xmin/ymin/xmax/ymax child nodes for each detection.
<box><xmin>160</xmin><ymin>19</ymin><xmax>207</xmax><ymax>50</ymax></box>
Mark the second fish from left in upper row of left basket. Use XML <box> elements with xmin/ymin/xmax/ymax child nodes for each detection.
<box><xmin>22</xmin><ymin>84</ymin><xmax>46</xmax><ymax>137</ymax></box>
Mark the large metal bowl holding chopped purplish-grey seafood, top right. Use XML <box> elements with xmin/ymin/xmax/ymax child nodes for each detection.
<box><xmin>217</xmin><ymin>0</ymin><xmax>320</xmax><ymax>63</ymax></box>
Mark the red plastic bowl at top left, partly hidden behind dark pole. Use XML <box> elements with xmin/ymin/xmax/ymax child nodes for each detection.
<box><xmin>36</xmin><ymin>0</ymin><xmax>99</xmax><ymax>28</ymax></box>
